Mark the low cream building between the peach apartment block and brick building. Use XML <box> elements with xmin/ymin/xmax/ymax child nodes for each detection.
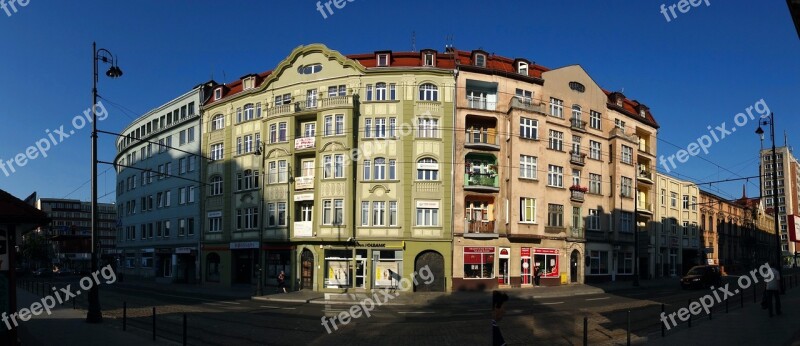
<box><xmin>648</xmin><ymin>173</ymin><xmax>700</xmax><ymax>278</ymax></box>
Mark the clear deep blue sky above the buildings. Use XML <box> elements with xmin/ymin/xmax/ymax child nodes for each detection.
<box><xmin>0</xmin><ymin>0</ymin><xmax>800</xmax><ymax>202</ymax></box>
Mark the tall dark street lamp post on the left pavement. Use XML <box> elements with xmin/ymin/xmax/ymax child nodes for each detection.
<box><xmin>86</xmin><ymin>42</ymin><xmax>122</xmax><ymax>323</ymax></box>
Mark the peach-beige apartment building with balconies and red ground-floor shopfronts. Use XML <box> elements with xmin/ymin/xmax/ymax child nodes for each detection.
<box><xmin>453</xmin><ymin>50</ymin><xmax>658</xmax><ymax>290</ymax></box>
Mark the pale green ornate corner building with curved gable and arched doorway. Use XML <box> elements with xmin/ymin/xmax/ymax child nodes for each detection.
<box><xmin>202</xmin><ymin>44</ymin><xmax>454</xmax><ymax>292</ymax></box>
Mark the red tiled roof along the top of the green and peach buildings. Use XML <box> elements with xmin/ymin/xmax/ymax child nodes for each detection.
<box><xmin>207</xmin><ymin>49</ymin><xmax>659</xmax><ymax>128</ymax></box>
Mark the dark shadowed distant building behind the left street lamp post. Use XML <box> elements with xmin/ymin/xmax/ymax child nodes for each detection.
<box><xmin>36</xmin><ymin>198</ymin><xmax>117</xmax><ymax>271</ymax></box>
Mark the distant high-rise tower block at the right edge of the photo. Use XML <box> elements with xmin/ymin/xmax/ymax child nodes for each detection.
<box><xmin>759</xmin><ymin>146</ymin><xmax>800</xmax><ymax>264</ymax></box>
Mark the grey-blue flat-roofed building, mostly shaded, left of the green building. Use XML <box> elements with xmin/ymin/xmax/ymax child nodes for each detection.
<box><xmin>115</xmin><ymin>84</ymin><xmax>213</xmax><ymax>283</ymax></box>
